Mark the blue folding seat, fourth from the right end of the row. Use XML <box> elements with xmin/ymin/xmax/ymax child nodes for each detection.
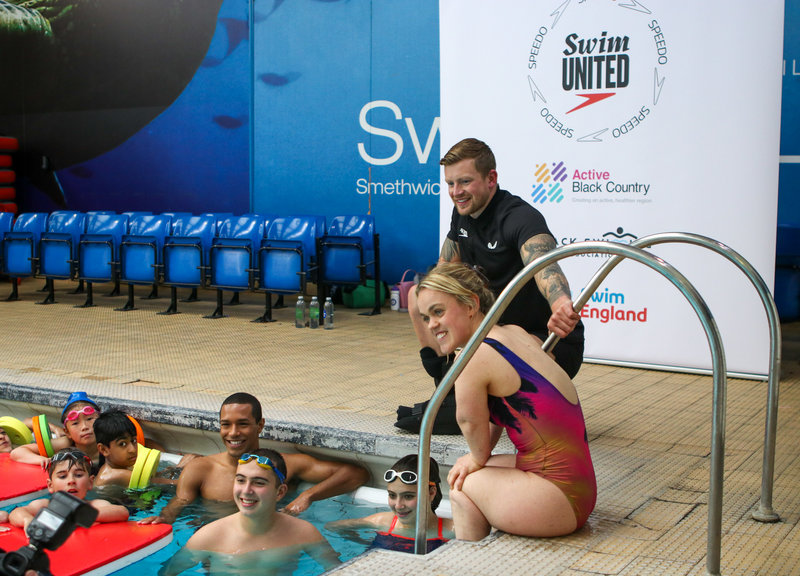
<box><xmin>160</xmin><ymin>215</ymin><xmax>217</xmax><ymax>314</ymax></box>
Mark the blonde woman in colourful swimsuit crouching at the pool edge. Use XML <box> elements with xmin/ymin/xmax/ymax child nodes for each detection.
<box><xmin>417</xmin><ymin>263</ymin><xmax>597</xmax><ymax>540</ymax></box>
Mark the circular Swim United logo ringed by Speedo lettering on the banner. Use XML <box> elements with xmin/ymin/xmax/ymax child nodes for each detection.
<box><xmin>526</xmin><ymin>0</ymin><xmax>669</xmax><ymax>143</ymax></box>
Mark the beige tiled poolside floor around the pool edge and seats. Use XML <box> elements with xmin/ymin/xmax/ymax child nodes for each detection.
<box><xmin>0</xmin><ymin>280</ymin><xmax>800</xmax><ymax>576</ymax></box>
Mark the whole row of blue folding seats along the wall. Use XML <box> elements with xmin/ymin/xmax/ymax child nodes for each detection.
<box><xmin>0</xmin><ymin>211</ymin><xmax>380</xmax><ymax>322</ymax></box>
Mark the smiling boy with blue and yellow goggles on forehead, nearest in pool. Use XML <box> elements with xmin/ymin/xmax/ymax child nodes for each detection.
<box><xmin>159</xmin><ymin>448</ymin><xmax>339</xmax><ymax>576</ymax></box>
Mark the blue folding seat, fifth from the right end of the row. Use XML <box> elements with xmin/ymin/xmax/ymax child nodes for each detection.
<box><xmin>119</xmin><ymin>214</ymin><xmax>172</xmax><ymax>311</ymax></box>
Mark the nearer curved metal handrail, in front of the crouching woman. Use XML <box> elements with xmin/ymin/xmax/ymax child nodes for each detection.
<box><xmin>414</xmin><ymin>242</ymin><xmax>727</xmax><ymax>576</ymax></box>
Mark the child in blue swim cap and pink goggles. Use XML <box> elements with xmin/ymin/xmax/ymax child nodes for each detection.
<box><xmin>11</xmin><ymin>392</ymin><xmax>100</xmax><ymax>469</ymax></box>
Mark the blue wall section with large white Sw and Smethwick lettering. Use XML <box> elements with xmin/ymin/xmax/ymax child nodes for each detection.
<box><xmin>253</xmin><ymin>0</ymin><xmax>440</xmax><ymax>282</ymax></box>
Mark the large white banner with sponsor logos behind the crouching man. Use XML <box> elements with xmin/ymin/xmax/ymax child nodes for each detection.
<box><xmin>440</xmin><ymin>0</ymin><xmax>783</xmax><ymax>374</ymax></box>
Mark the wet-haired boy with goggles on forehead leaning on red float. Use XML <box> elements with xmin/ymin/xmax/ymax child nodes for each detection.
<box><xmin>8</xmin><ymin>448</ymin><xmax>128</xmax><ymax>530</ymax></box>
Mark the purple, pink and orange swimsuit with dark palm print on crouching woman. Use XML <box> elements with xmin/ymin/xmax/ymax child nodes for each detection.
<box><xmin>484</xmin><ymin>338</ymin><xmax>597</xmax><ymax>528</ymax></box>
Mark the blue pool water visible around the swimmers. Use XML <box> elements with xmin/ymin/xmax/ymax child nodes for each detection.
<box><xmin>3</xmin><ymin>487</ymin><xmax>388</xmax><ymax>576</ymax></box>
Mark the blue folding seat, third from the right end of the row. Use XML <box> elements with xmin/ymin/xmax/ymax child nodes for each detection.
<box><xmin>207</xmin><ymin>214</ymin><xmax>264</xmax><ymax>318</ymax></box>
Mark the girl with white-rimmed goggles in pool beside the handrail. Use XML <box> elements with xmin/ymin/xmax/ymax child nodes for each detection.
<box><xmin>325</xmin><ymin>454</ymin><xmax>455</xmax><ymax>552</ymax></box>
